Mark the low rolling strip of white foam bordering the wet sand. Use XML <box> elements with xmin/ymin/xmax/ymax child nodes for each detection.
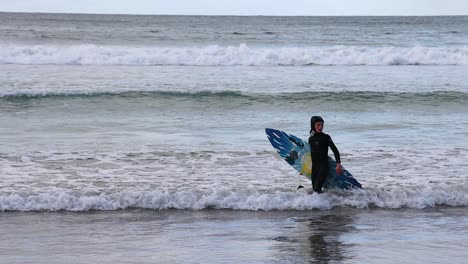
<box><xmin>0</xmin><ymin>185</ymin><xmax>468</xmax><ymax>211</ymax></box>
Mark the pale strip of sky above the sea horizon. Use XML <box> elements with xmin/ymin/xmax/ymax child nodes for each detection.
<box><xmin>0</xmin><ymin>0</ymin><xmax>468</xmax><ymax>16</ymax></box>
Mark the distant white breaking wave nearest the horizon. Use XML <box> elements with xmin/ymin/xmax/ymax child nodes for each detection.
<box><xmin>0</xmin><ymin>44</ymin><xmax>468</xmax><ymax>66</ymax></box>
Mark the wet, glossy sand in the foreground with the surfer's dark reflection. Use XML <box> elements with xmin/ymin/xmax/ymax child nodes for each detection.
<box><xmin>0</xmin><ymin>207</ymin><xmax>468</xmax><ymax>263</ymax></box>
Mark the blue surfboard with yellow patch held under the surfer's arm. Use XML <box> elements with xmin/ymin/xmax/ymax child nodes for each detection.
<box><xmin>265</xmin><ymin>128</ymin><xmax>362</xmax><ymax>189</ymax></box>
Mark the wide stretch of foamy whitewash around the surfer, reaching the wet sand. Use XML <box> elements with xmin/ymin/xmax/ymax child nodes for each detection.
<box><xmin>0</xmin><ymin>146</ymin><xmax>468</xmax><ymax>211</ymax></box>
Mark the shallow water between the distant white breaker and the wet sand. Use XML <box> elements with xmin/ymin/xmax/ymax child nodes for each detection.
<box><xmin>0</xmin><ymin>65</ymin><xmax>468</xmax><ymax>211</ymax></box>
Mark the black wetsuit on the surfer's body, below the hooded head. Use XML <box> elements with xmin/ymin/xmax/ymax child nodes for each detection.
<box><xmin>309</xmin><ymin>133</ymin><xmax>341</xmax><ymax>193</ymax></box>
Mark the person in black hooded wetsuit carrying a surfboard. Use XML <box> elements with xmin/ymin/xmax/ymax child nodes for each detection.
<box><xmin>309</xmin><ymin>116</ymin><xmax>343</xmax><ymax>193</ymax></box>
